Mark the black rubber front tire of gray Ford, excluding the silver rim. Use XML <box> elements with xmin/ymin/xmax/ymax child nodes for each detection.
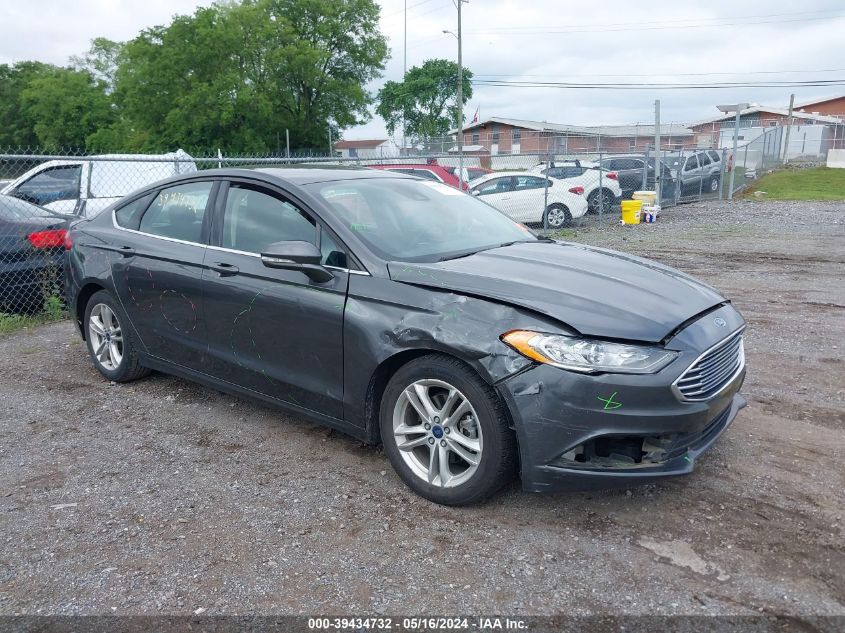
<box><xmin>379</xmin><ymin>354</ymin><xmax>517</xmax><ymax>506</ymax></box>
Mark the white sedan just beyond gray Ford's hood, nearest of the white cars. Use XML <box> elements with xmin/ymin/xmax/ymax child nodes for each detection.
<box><xmin>469</xmin><ymin>171</ymin><xmax>587</xmax><ymax>229</ymax></box>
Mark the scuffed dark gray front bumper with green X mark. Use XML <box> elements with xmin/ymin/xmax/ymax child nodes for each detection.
<box><xmin>498</xmin><ymin>306</ymin><xmax>746</xmax><ymax>492</ymax></box>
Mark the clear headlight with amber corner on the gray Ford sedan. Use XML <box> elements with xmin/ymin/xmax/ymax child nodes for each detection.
<box><xmin>501</xmin><ymin>330</ymin><xmax>677</xmax><ymax>374</ymax></box>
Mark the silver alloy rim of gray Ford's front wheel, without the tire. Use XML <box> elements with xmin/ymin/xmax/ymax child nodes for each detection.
<box><xmin>393</xmin><ymin>379</ymin><xmax>484</xmax><ymax>488</ymax></box>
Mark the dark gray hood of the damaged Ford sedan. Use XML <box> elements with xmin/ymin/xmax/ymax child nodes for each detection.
<box><xmin>388</xmin><ymin>242</ymin><xmax>725</xmax><ymax>342</ymax></box>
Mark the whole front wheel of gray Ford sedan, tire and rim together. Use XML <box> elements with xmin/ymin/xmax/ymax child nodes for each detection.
<box><xmin>380</xmin><ymin>354</ymin><xmax>517</xmax><ymax>506</ymax></box>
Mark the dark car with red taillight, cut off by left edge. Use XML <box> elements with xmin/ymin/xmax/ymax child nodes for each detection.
<box><xmin>0</xmin><ymin>195</ymin><xmax>67</xmax><ymax>312</ymax></box>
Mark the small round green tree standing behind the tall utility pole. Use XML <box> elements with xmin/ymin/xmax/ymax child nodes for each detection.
<box><xmin>376</xmin><ymin>59</ymin><xmax>472</xmax><ymax>140</ymax></box>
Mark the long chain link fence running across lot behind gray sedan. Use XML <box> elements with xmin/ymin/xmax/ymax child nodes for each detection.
<box><xmin>0</xmin><ymin>124</ymin><xmax>832</xmax><ymax>312</ymax></box>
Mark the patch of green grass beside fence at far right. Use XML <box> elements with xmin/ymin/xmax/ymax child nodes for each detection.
<box><xmin>743</xmin><ymin>167</ymin><xmax>845</xmax><ymax>200</ymax></box>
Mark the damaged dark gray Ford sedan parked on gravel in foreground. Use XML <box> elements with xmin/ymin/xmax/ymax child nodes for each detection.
<box><xmin>67</xmin><ymin>168</ymin><xmax>745</xmax><ymax>505</ymax></box>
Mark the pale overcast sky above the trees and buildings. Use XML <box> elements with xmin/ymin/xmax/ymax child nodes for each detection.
<box><xmin>0</xmin><ymin>0</ymin><xmax>845</xmax><ymax>139</ymax></box>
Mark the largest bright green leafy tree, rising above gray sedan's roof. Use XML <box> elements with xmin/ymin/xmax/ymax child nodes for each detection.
<box><xmin>114</xmin><ymin>0</ymin><xmax>387</xmax><ymax>151</ymax></box>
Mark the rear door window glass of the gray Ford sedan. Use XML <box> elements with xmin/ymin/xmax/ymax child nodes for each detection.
<box><xmin>139</xmin><ymin>182</ymin><xmax>213</xmax><ymax>244</ymax></box>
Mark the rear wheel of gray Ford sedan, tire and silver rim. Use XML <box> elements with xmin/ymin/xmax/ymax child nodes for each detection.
<box><xmin>84</xmin><ymin>290</ymin><xmax>150</xmax><ymax>382</ymax></box>
